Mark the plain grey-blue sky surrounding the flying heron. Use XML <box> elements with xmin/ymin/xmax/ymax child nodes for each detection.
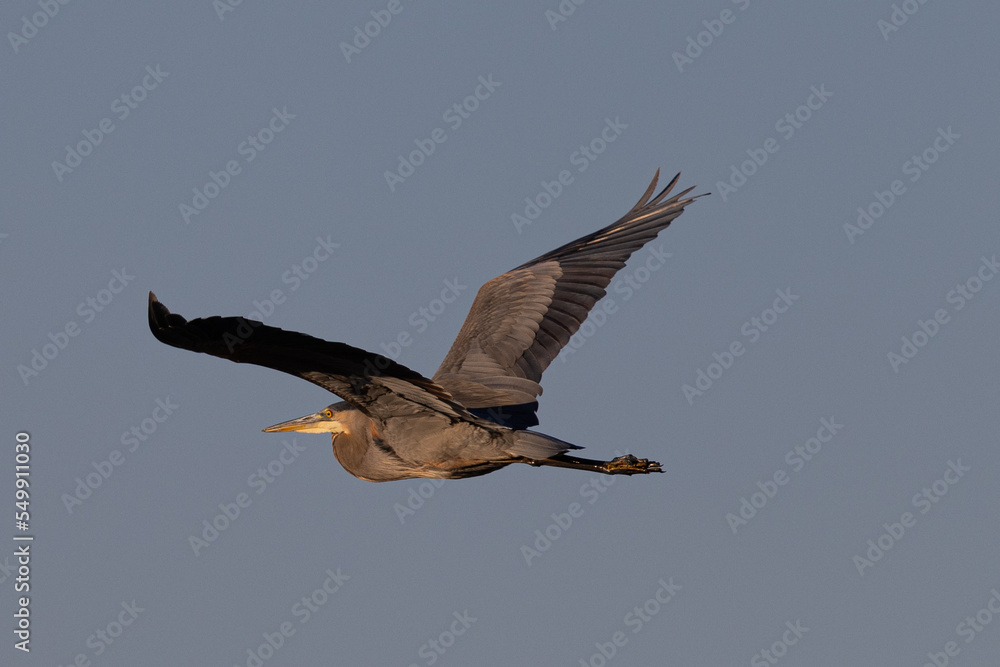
<box><xmin>0</xmin><ymin>0</ymin><xmax>1000</xmax><ymax>667</ymax></box>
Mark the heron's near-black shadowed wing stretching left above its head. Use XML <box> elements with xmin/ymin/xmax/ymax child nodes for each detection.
<box><xmin>149</xmin><ymin>292</ymin><xmax>474</xmax><ymax>428</ymax></box>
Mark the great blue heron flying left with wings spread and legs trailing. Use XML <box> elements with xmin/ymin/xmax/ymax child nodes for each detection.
<box><xmin>149</xmin><ymin>170</ymin><xmax>708</xmax><ymax>482</ymax></box>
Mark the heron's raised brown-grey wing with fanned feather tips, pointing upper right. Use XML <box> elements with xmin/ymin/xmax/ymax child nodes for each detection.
<box><xmin>434</xmin><ymin>170</ymin><xmax>701</xmax><ymax>428</ymax></box>
